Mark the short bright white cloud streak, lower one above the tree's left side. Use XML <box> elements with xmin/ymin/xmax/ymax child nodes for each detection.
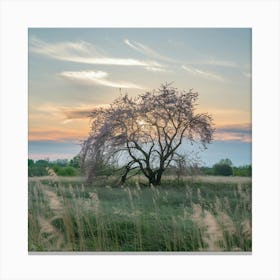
<box><xmin>59</xmin><ymin>71</ymin><xmax>143</xmax><ymax>89</ymax></box>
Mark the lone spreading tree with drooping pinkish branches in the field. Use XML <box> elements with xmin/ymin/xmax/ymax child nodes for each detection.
<box><xmin>81</xmin><ymin>84</ymin><xmax>214</xmax><ymax>185</ymax></box>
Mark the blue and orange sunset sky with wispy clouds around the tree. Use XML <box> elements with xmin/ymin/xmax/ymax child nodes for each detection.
<box><xmin>28</xmin><ymin>28</ymin><xmax>252</xmax><ymax>166</ymax></box>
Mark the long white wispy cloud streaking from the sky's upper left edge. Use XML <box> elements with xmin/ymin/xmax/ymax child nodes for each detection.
<box><xmin>30</xmin><ymin>38</ymin><xmax>161</xmax><ymax>67</ymax></box>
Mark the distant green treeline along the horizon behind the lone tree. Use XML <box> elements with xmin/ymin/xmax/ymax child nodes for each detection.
<box><xmin>28</xmin><ymin>156</ymin><xmax>252</xmax><ymax>178</ymax></box>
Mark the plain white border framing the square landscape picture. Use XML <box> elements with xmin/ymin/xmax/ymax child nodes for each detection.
<box><xmin>0</xmin><ymin>0</ymin><xmax>280</xmax><ymax>280</ymax></box>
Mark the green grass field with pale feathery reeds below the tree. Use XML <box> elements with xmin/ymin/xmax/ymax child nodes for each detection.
<box><xmin>28</xmin><ymin>176</ymin><xmax>252</xmax><ymax>252</ymax></box>
